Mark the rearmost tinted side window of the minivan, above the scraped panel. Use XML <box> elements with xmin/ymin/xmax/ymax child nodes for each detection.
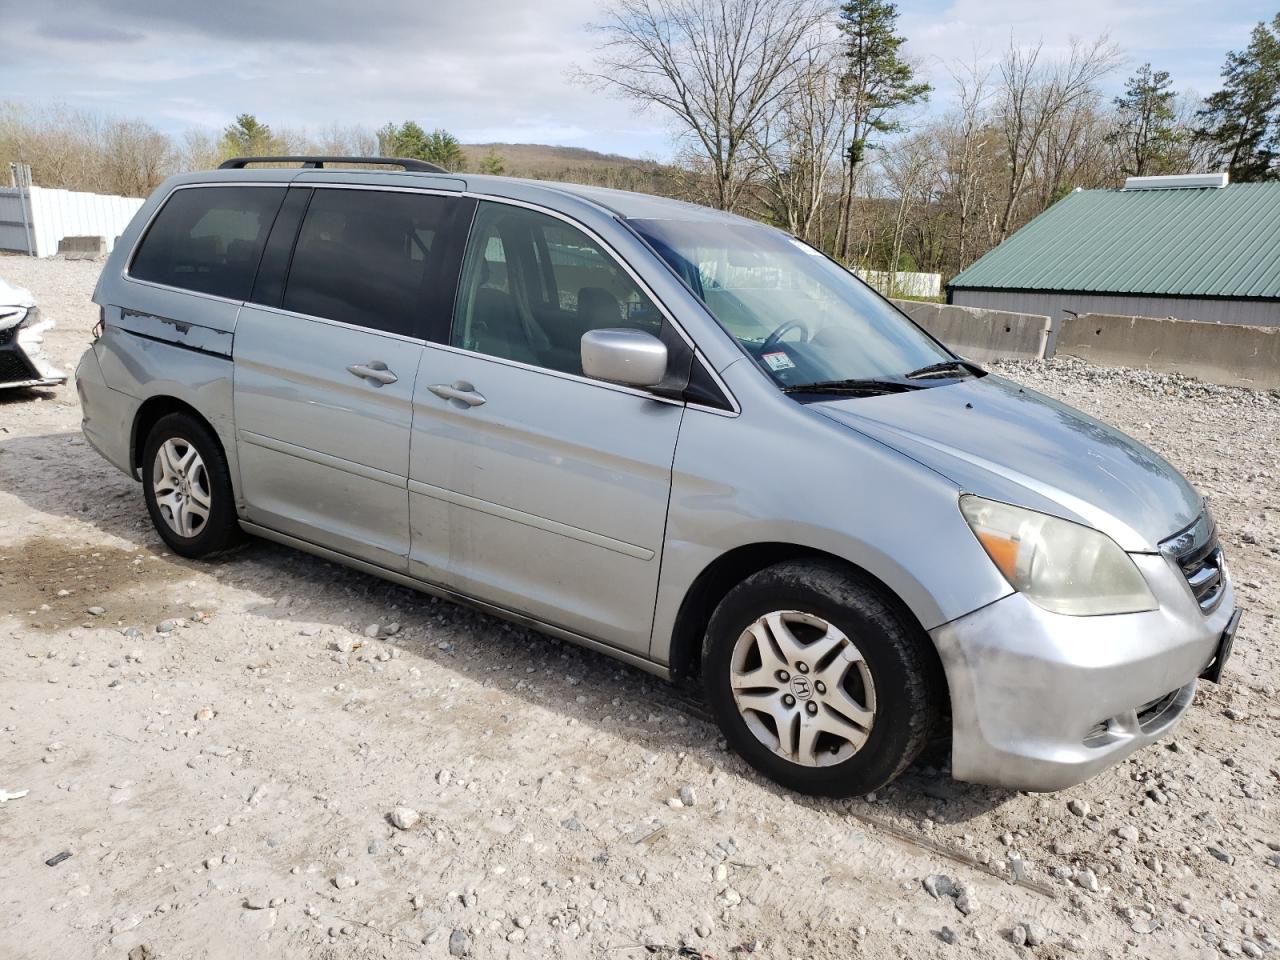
<box><xmin>129</xmin><ymin>186</ymin><xmax>284</xmax><ymax>300</ymax></box>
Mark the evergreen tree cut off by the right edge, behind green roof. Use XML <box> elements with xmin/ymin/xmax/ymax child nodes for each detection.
<box><xmin>1198</xmin><ymin>14</ymin><xmax>1280</xmax><ymax>182</ymax></box>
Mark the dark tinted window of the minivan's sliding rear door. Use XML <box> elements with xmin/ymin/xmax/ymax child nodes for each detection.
<box><xmin>283</xmin><ymin>189</ymin><xmax>456</xmax><ymax>337</ymax></box>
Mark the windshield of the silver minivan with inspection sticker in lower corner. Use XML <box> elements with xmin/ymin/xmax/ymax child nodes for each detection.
<box><xmin>630</xmin><ymin>220</ymin><xmax>955</xmax><ymax>388</ymax></box>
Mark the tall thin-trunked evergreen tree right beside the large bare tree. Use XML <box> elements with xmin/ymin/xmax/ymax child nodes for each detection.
<box><xmin>837</xmin><ymin>0</ymin><xmax>932</xmax><ymax>257</ymax></box>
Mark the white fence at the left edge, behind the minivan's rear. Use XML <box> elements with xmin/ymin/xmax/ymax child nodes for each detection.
<box><xmin>0</xmin><ymin>187</ymin><xmax>142</xmax><ymax>257</ymax></box>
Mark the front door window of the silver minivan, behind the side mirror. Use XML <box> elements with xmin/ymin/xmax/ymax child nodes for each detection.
<box><xmin>452</xmin><ymin>204</ymin><xmax>663</xmax><ymax>375</ymax></box>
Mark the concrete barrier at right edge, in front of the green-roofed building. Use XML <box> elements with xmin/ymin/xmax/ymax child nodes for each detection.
<box><xmin>1057</xmin><ymin>314</ymin><xmax>1280</xmax><ymax>390</ymax></box>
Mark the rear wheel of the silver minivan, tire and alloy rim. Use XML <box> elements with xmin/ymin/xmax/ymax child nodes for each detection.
<box><xmin>142</xmin><ymin>413</ymin><xmax>242</xmax><ymax>558</ymax></box>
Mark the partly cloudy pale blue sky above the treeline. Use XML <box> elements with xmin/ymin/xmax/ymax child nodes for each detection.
<box><xmin>0</xmin><ymin>0</ymin><xmax>1280</xmax><ymax>159</ymax></box>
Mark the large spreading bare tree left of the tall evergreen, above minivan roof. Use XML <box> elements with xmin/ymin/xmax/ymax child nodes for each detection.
<box><xmin>579</xmin><ymin>0</ymin><xmax>826</xmax><ymax>210</ymax></box>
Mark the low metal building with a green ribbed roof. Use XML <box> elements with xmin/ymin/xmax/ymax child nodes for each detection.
<box><xmin>947</xmin><ymin>173</ymin><xmax>1280</xmax><ymax>326</ymax></box>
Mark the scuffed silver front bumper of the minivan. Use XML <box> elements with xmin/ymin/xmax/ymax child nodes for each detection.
<box><xmin>932</xmin><ymin>554</ymin><xmax>1235</xmax><ymax>791</ymax></box>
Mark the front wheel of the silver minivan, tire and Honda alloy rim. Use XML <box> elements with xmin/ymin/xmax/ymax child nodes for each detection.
<box><xmin>703</xmin><ymin>561</ymin><xmax>943</xmax><ymax>796</ymax></box>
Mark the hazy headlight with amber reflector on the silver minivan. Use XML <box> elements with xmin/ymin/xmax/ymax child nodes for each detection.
<box><xmin>960</xmin><ymin>495</ymin><xmax>1157</xmax><ymax>617</ymax></box>
